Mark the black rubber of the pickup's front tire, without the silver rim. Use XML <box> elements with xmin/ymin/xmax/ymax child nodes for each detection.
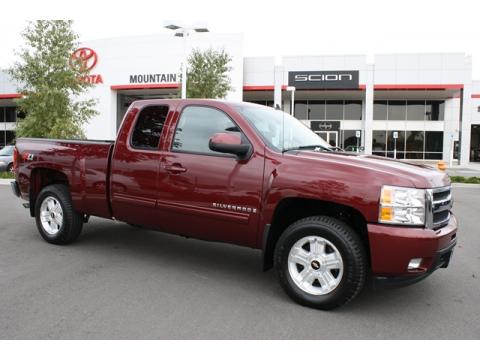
<box><xmin>275</xmin><ymin>218</ymin><xmax>364</xmax><ymax>309</ymax></box>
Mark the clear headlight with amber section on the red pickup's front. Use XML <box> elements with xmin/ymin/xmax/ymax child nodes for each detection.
<box><xmin>378</xmin><ymin>185</ymin><xmax>425</xmax><ymax>225</ymax></box>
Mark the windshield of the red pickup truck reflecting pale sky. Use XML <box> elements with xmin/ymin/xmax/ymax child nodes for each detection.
<box><xmin>237</xmin><ymin>105</ymin><xmax>330</xmax><ymax>151</ymax></box>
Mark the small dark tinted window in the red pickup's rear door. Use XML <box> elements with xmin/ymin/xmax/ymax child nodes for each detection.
<box><xmin>132</xmin><ymin>106</ymin><xmax>168</xmax><ymax>149</ymax></box>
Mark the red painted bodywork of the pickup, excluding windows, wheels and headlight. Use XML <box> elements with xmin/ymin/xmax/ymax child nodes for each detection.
<box><xmin>16</xmin><ymin>100</ymin><xmax>456</xmax><ymax>275</ymax></box>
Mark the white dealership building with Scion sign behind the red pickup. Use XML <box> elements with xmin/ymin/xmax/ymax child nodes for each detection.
<box><xmin>0</xmin><ymin>33</ymin><xmax>480</xmax><ymax>165</ymax></box>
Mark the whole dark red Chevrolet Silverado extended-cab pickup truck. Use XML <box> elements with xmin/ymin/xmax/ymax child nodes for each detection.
<box><xmin>12</xmin><ymin>100</ymin><xmax>457</xmax><ymax>309</ymax></box>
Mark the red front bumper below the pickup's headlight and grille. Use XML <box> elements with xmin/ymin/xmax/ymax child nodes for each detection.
<box><xmin>368</xmin><ymin>214</ymin><xmax>457</xmax><ymax>284</ymax></box>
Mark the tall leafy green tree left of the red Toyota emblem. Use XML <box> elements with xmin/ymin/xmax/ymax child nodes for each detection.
<box><xmin>8</xmin><ymin>20</ymin><xmax>97</xmax><ymax>139</ymax></box>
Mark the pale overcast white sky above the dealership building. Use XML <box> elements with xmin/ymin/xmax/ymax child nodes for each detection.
<box><xmin>0</xmin><ymin>0</ymin><xmax>480</xmax><ymax>79</ymax></box>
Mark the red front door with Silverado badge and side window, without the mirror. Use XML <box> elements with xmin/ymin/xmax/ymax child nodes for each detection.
<box><xmin>157</xmin><ymin>105</ymin><xmax>264</xmax><ymax>247</ymax></box>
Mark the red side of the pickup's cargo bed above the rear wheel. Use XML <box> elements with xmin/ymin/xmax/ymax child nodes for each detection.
<box><xmin>16</xmin><ymin>138</ymin><xmax>114</xmax><ymax>218</ymax></box>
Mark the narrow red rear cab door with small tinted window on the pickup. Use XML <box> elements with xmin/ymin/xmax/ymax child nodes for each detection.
<box><xmin>111</xmin><ymin>104</ymin><xmax>169</xmax><ymax>227</ymax></box>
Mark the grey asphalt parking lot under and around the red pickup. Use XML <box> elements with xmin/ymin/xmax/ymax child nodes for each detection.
<box><xmin>0</xmin><ymin>186</ymin><xmax>480</xmax><ymax>339</ymax></box>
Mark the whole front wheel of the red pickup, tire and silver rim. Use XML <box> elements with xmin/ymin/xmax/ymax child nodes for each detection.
<box><xmin>274</xmin><ymin>216</ymin><xmax>367</xmax><ymax>310</ymax></box>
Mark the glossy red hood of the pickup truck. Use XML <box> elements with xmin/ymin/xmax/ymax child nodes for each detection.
<box><xmin>296</xmin><ymin>151</ymin><xmax>450</xmax><ymax>189</ymax></box>
